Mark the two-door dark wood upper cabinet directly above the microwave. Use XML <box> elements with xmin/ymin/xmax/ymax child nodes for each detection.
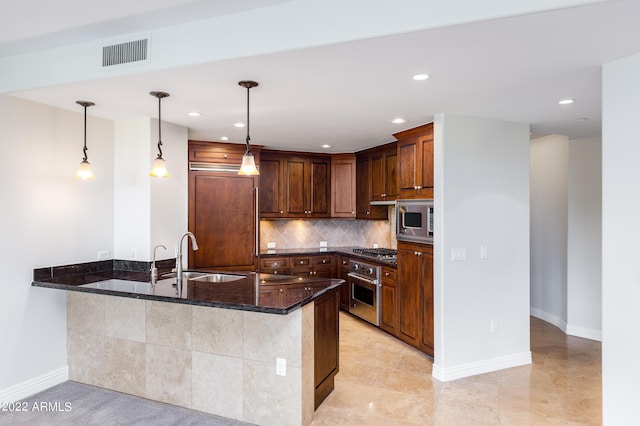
<box><xmin>393</xmin><ymin>123</ymin><xmax>433</xmax><ymax>198</ymax></box>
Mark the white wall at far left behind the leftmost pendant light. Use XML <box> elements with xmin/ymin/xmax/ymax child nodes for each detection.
<box><xmin>0</xmin><ymin>96</ymin><xmax>113</xmax><ymax>401</ymax></box>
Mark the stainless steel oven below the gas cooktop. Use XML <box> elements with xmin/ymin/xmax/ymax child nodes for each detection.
<box><xmin>349</xmin><ymin>259</ymin><xmax>381</xmax><ymax>325</ymax></box>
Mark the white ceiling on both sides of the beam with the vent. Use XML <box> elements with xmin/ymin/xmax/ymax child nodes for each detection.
<box><xmin>0</xmin><ymin>0</ymin><xmax>640</xmax><ymax>152</ymax></box>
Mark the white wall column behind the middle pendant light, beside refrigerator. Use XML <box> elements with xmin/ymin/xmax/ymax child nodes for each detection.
<box><xmin>114</xmin><ymin>118</ymin><xmax>188</xmax><ymax>261</ymax></box>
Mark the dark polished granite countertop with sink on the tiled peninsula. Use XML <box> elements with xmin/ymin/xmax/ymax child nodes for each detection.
<box><xmin>32</xmin><ymin>261</ymin><xmax>344</xmax><ymax>315</ymax></box>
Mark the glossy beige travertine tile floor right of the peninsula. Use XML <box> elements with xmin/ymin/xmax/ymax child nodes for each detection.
<box><xmin>312</xmin><ymin>312</ymin><xmax>602</xmax><ymax>426</ymax></box>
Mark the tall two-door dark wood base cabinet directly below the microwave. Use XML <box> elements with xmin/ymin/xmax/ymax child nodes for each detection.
<box><xmin>395</xmin><ymin>242</ymin><xmax>433</xmax><ymax>356</ymax></box>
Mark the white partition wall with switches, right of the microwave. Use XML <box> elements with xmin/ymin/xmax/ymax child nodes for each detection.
<box><xmin>433</xmin><ymin>114</ymin><xmax>531</xmax><ymax>380</ymax></box>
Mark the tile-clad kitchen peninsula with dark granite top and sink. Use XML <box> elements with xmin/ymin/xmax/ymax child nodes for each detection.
<box><xmin>33</xmin><ymin>262</ymin><xmax>342</xmax><ymax>425</ymax></box>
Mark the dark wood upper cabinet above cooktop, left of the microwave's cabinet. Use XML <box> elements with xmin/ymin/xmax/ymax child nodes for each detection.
<box><xmin>370</xmin><ymin>142</ymin><xmax>398</xmax><ymax>202</ymax></box>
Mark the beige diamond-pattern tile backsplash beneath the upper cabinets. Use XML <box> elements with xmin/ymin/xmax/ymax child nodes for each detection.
<box><xmin>260</xmin><ymin>208</ymin><xmax>397</xmax><ymax>250</ymax></box>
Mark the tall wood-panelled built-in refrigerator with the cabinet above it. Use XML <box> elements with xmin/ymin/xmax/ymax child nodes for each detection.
<box><xmin>188</xmin><ymin>141</ymin><xmax>259</xmax><ymax>271</ymax></box>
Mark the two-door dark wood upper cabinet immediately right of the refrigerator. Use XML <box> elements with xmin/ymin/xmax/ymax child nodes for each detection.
<box><xmin>260</xmin><ymin>151</ymin><xmax>331</xmax><ymax>219</ymax></box>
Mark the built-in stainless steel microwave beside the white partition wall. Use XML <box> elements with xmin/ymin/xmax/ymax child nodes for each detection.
<box><xmin>396</xmin><ymin>198</ymin><xmax>433</xmax><ymax>244</ymax></box>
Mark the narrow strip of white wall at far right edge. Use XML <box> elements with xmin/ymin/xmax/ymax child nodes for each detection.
<box><xmin>602</xmin><ymin>50</ymin><xmax>640</xmax><ymax>425</ymax></box>
